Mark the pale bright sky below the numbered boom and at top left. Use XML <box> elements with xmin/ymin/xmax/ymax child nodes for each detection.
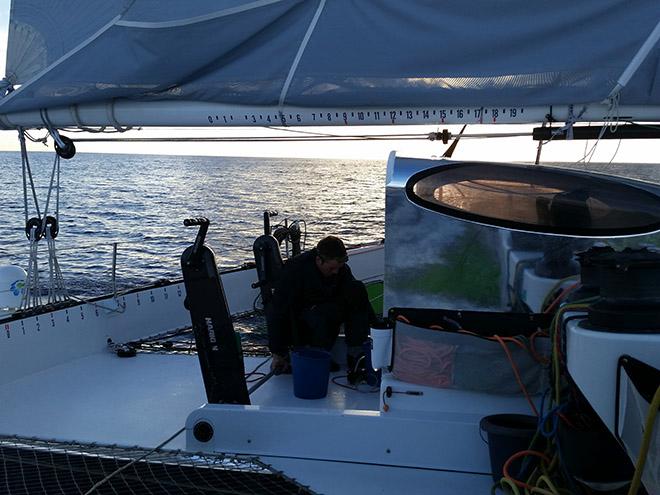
<box><xmin>0</xmin><ymin>0</ymin><xmax>658</xmax><ymax>163</ymax></box>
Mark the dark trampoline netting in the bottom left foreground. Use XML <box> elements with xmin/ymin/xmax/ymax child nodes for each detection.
<box><xmin>0</xmin><ymin>437</ymin><xmax>313</xmax><ymax>495</ymax></box>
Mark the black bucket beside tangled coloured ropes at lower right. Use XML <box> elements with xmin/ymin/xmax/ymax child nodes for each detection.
<box><xmin>479</xmin><ymin>414</ymin><xmax>537</xmax><ymax>481</ymax></box>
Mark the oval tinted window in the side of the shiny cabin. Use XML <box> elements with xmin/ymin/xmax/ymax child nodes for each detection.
<box><xmin>407</xmin><ymin>162</ymin><xmax>660</xmax><ymax>236</ymax></box>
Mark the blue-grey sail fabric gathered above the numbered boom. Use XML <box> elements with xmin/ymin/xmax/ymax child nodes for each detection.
<box><xmin>0</xmin><ymin>0</ymin><xmax>660</xmax><ymax>113</ymax></box>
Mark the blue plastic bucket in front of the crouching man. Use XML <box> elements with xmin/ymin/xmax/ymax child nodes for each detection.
<box><xmin>291</xmin><ymin>349</ymin><xmax>330</xmax><ymax>399</ymax></box>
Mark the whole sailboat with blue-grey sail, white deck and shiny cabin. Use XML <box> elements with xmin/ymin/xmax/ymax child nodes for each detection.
<box><xmin>0</xmin><ymin>0</ymin><xmax>660</xmax><ymax>495</ymax></box>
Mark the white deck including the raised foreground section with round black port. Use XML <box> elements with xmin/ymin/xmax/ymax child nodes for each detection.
<box><xmin>0</xmin><ymin>310</ymin><xmax>517</xmax><ymax>494</ymax></box>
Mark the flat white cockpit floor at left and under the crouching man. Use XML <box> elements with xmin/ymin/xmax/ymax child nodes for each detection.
<box><xmin>0</xmin><ymin>352</ymin><xmax>378</xmax><ymax>449</ymax></box>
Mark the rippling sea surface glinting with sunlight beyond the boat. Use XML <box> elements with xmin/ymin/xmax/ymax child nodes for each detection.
<box><xmin>0</xmin><ymin>152</ymin><xmax>660</xmax><ymax>296</ymax></box>
